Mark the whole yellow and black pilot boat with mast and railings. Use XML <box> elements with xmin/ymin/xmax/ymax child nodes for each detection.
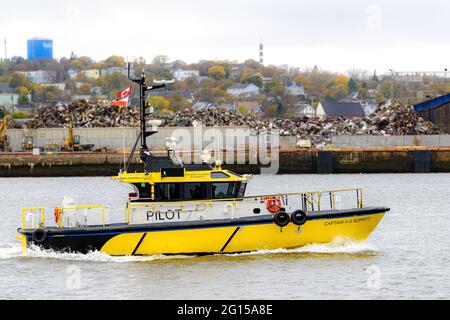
<box><xmin>18</xmin><ymin>66</ymin><xmax>390</xmax><ymax>256</ymax></box>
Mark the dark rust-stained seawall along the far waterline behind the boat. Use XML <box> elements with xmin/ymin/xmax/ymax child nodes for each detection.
<box><xmin>0</xmin><ymin>148</ymin><xmax>450</xmax><ymax>177</ymax></box>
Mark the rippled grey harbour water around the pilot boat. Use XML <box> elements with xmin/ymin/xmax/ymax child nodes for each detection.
<box><xmin>0</xmin><ymin>174</ymin><xmax>450</xmax><ymax>299</ymax></box>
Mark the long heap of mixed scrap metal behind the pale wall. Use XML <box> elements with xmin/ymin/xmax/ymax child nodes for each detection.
<box><xmin>22</xmin><ymin>100</ymin><xmax>442</xmax><ymax>145</ymax></box>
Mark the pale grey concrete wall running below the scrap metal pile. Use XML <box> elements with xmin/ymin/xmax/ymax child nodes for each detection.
<box><xmin>7</xmin><ymin>127</ymin><xmax>450</xmax><ymax>152</ymax></box>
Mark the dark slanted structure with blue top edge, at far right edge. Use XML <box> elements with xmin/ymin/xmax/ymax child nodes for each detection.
<box><xmin>414</xmin><ymin>93</ymin><xmax>450</xmax><ymax>133</ymax></box>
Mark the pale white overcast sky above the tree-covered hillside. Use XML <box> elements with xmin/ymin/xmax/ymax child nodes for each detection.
<box><xmin>0</xmin><ymin>0</ymin><xmax>450</xmax><ymax>73</ymax></box>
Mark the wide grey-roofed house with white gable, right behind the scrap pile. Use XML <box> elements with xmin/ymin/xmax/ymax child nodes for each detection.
<box><xmin>316</xmin><ymin>101</ymin><xmax>364</xmax><ymax>118</ymax></box>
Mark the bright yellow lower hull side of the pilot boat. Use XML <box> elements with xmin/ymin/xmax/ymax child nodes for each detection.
<box><xmin>100</xmin><ymin>213</ymin><xmax>384</xmax><ymax>256</ymax></box>
